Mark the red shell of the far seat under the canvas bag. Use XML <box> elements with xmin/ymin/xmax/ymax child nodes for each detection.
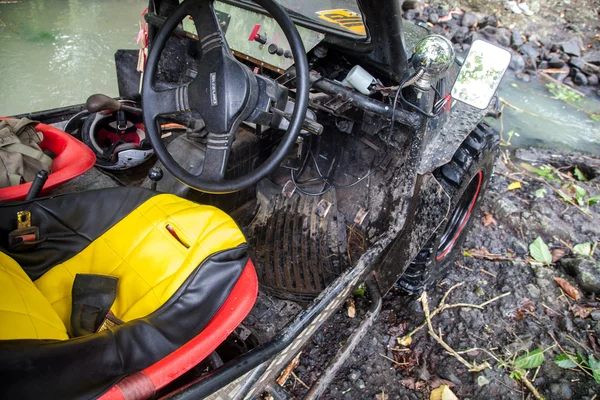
<box><xmin>0</xmin><ymin>117</ymin><xmax>96</xmax><ymax>200</ymax></box>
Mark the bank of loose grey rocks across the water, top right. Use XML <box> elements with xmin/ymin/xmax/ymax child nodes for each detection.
<box><xmin>403</xmin><ymin>0</ymin><xmax>600</xmax><ymax>96</ymax></box>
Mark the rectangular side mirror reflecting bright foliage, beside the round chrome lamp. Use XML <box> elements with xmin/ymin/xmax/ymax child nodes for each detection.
<box><xmin>451</xmin><ymin>40</ymin><xmax>511</xmax><ymax>110</ymax></box>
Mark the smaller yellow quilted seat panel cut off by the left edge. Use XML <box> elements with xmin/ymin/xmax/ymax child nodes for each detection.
<box><xmin>0</xmin><ymin>252</ymin><xmax>69</xmax><ymax>340</ymax></box>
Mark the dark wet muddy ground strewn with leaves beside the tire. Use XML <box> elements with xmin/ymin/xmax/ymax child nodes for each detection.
<box><xmin>285</xmin><ymin>149</ymin><xmax>600</xmax><ymax>400</ymax></box>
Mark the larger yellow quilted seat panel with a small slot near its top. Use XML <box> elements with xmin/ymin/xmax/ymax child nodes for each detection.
<box><xmin>34</xmin><ymin>194</ymin><xmax>245</xmax><ymax>332</ymax></box>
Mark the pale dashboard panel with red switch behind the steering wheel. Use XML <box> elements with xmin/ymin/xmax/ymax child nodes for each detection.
<box><xmin>183</xmin><ymin>1</ymin><xmax>325</xmax><ymax>73</ymax></box>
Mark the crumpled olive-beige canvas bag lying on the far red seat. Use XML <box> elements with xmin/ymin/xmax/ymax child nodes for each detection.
<box><xmin>0</xmin><ymin>118</ymin><xmax>52</xmax><ymax>188</ymax></box>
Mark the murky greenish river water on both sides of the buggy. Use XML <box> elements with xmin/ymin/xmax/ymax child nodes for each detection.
<box><xmin>0</xmin><ymin>0</ymin><xmax>600</xmax><ymax>155</ymax></box>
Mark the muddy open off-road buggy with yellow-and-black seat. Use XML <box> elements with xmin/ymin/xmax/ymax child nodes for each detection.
<box><xmin>0</xmin><ymin>0</ymin><xmax>507</xmax><ymax>399</ymax></box>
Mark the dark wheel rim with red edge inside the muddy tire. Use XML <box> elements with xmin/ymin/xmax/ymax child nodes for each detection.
<box><xmin>435</xmin><ymin>171</ymin><xmax>483</xmax><ymax>261</ymax></box>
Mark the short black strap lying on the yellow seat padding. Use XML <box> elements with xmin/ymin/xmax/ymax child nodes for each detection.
<box><xmin>71</xmin><ymin>274</ymin><xmax>119</xmax><ymax>337</ymax></box>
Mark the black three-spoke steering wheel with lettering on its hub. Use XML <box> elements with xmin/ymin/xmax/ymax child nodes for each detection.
<box><xmin>142</xmin><ymin>0</ymin><xmax>310</xmax><ymax>193</ymax></box>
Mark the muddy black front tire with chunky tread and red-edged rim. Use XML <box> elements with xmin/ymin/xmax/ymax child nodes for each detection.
<box><xmin>398</xmin><ymin>123</ymin><xmax>499</xmax><ymax>294</ymax></box>
